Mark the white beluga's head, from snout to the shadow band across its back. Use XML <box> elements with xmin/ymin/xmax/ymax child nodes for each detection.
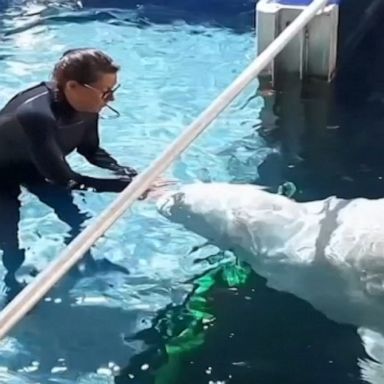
<box><xmin>157</xmin><ymin>183</ymin><xmax>321</xmax><ymax>270</ymax></box>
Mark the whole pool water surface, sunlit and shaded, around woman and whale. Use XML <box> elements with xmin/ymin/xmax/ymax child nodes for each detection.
<box><xmin>0</xmin><ymin>0</ymin><xmax>384</xmax><ymax>384</ymax></box>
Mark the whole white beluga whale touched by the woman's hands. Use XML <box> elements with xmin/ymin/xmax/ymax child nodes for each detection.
<box><xmin>157</xmin><ymin>183</ymin><xmax>384</xmax><ymax>380</ymax></box>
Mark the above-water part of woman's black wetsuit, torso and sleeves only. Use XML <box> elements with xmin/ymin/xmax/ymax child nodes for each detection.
<box><xmin>0</xmin><ymin>82</ymin><xmax>137</xmax><ymax>192</ymax></box>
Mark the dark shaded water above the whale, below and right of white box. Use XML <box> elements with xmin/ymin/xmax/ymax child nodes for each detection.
<box><xmin>254</xmin><ymin>1</ymin><xmax>384</xmax><ymax>200</ymax></box>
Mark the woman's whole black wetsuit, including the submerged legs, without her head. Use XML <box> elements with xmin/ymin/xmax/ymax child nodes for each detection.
<box><xmin>0</xmin><ymin>83</ymin><xmax>136</xmax><ymax>299</ymax></box>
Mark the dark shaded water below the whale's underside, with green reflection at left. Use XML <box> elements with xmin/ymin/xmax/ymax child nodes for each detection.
<box><xmin>115</xmin><ymin>269</ymin><xmax>367</xmax><ymax>384</ymax></box>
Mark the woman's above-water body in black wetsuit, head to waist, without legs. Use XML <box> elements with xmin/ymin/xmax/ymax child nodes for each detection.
<box><xmin>0</xmin><ymin>49</ymin><xmax>141</xmax><ymax>191</ymax></box>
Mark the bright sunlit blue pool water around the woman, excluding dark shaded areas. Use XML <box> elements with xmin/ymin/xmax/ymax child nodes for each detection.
<box><xmin>0</xmin><ymin>3</ymin><xmax>271</xmax><ymax>383</ymax></box>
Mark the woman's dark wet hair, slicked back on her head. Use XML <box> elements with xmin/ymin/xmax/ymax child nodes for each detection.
<box><xmin>52</xmin><ymin>48</ymin><xmax>120</xmax><ymax>88</ymax></box>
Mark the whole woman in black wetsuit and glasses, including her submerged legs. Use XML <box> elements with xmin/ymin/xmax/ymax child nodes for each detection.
<box><xmin>0</xmin><ymin>49</ymin><xmax>162</xmax><ymax>296</ymax></box>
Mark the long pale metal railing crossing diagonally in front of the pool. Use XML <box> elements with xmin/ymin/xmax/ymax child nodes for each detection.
<box><xmin>0</xmin><ymin>0</ymin><xmax>328</xmax><ymax>339</ymax></box>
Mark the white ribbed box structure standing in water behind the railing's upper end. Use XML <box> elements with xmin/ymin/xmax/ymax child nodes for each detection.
<box><xmin>256</xmin><ymin>0</ymin><xmax>339</xmax><ymax>83</ymax></box>
